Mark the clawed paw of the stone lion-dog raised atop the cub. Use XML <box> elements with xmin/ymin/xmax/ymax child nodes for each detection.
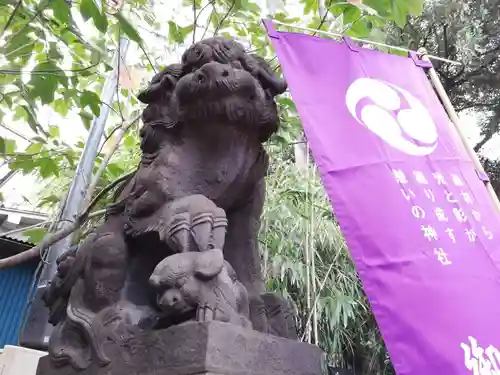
<box><xmin>165</xmin><ymin>195</ymin><xmax>227</xmax><ymax>252</ymax></box>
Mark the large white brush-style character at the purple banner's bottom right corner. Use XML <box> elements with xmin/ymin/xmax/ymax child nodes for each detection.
<box><xmin>460</xmin><ymin>336</ymin><xmax>500</xmax><ymax>375</ymax></box>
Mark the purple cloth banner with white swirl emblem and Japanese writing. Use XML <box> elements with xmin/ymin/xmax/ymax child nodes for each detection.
<box><xmin>265</xmin><ymin>21</ymin><xmax>500</xmax><ymax>375</ymax></box>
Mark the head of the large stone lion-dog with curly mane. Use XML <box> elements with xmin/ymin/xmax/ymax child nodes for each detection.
<box><xmin>138</xmin><ymin>37</ymin><xmax>286</xmax><ymax>154</ymax></box>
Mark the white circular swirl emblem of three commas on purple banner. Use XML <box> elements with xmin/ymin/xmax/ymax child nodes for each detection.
<box><xmin>345</xmin><ymin>78</ymin><xmax>438</xmax><ymax>156</ymax></box>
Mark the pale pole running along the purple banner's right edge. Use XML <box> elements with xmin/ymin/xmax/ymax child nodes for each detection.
<box><xmin>417</xmin><ymin>48</ymin><xmax>500</xmax><ymax>212</ymax></box>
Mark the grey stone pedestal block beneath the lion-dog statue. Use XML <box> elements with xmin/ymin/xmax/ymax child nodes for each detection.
<box><xmin>37</xmin><ymin>322</ymin><xmax>326</xmax><ymax>375</ymax></box>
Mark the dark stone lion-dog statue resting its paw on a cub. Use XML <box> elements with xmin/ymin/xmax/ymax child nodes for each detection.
<box><xmin>44</xmin><ymin>37</ymin><xmax>296</xmax><ymax>369</ymax></box>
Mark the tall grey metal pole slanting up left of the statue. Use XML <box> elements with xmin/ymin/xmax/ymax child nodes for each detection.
<box><xmin>20</xmin><ymin>38</ymin><xmax>129</xmax><ymax>350</ymax></box>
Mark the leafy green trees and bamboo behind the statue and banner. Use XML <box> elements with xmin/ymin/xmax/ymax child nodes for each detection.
<box><xmin>0</xmin><ymin>0</ymin><xmax>500</xmax><ymax>374</ymax></box>
